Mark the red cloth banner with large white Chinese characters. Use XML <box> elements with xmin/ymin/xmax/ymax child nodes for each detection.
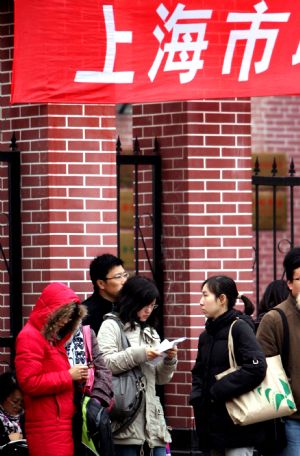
<box><xmin>12</xmin><ymin>0</ymin><xmax>300</xmax><ymax>103</ymax></box>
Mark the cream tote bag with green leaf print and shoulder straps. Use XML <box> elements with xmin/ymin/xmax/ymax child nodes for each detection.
<box><xmin>216</xmin><ymin>320</ymin><xmax>297</xmax><ymax>426</ymax></box>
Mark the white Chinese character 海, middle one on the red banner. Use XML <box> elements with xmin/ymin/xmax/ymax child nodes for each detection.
<box><xmin>148</xmin><ymin>3</ymin><xmax>212</xmax><ymax>84</ymax></box>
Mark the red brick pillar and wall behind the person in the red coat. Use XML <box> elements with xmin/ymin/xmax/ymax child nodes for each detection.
<box><xmin>0</xmin><ymin>1</ymin><xmax>117</xmax><ymax>342</ymax></box>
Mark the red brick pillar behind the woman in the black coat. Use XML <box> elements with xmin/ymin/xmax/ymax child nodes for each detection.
<box><xmin>133</xmin><ymin>99</ymin><xmax>253</xmax><ymax>428</ymax></box>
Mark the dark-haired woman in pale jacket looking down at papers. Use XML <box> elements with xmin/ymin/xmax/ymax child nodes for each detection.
<box><xmin>97</xmin><ymin>276</ymin><xmax>177</xmax><ymax>456</ymax></box>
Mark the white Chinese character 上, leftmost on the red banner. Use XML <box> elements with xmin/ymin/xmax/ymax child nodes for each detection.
<box><xmin>74</xmin><ymin>5</ymin><xmax>134</xmax><ymax>84</ymax></box>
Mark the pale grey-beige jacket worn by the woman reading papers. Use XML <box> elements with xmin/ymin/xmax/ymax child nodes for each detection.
<box><xmin>97</xmin><ymin>314</ymin><xmax>177</xmax><ymax>448</ymax></box>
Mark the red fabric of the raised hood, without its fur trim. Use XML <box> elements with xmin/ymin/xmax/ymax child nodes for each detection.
<box><xmin>29</xmin><ymin>282</ymin><xmax>80</xmax><ymax>331</ymax></box>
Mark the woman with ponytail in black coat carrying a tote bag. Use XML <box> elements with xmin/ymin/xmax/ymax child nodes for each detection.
<box><xmin>190</xmin><ymin>276</ymin><xmax>266</xmax><ymax>456</ymax></box>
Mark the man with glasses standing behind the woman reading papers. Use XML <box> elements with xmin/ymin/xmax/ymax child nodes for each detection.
<box><xmin>83</xmin><ymin>253</ymin><xmax>129</xmax><ymax>335</ymax></box>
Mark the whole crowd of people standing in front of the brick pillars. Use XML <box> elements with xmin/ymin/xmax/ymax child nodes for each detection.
<box><xmin>0</xmin><ymin>247</ymin><xmax>300</xmax><ymax>456</ymax></box>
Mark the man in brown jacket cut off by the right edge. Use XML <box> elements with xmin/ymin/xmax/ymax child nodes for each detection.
<box><xmin>257</xmin><ymin>247</ymin><xmax>300</xmax><ymax>456</ymax></box>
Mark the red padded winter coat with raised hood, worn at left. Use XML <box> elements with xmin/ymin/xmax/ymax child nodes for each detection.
<box><xmin>15</xmin><ymin>283</ymin><xmax>80</xmax><ymax>456</ymax></box>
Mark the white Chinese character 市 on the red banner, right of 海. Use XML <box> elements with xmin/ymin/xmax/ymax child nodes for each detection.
<box><xmin>222</xmin><ymin>1</ymin><xmax>290</xmax><ymax>81</ymax></box>
